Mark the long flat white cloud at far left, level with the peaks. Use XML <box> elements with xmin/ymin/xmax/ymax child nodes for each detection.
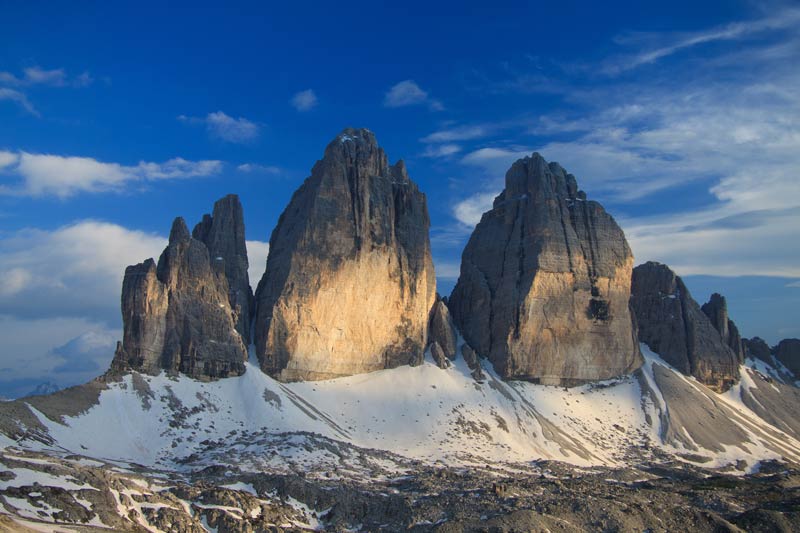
<box><xmin>0</xmin><ymin>152</ymin><xmax>222</xmax><ymax>198</ymax></box>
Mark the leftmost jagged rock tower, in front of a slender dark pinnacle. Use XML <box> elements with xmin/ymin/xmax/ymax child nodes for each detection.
<box><xmin>111</xmin><ymin>208</ymin><xmax>247</xmax><ymax>379</ymax></box>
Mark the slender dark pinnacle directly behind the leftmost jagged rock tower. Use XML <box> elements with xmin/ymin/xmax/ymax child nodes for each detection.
<box><xmin>192</xmin><ymin>194</ymin><xmax>254</xmax><ymax>338</ymax></box>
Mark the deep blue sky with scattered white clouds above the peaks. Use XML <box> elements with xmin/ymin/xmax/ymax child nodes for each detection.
<box><xmin>0</xmin><ymin>1</ymin><xmax>800</xmax><ymax>396</ymax></box>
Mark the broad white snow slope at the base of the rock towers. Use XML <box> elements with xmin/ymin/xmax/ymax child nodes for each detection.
<box><xmin>6</xmin><ymin>345</ymin><xmax>800</xmax><ymax>475</ymax></box>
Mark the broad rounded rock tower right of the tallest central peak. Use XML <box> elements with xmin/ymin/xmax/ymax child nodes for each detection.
<box><xmin>448</xmin><ymin>154</ymin><xmax>642</xmax><ymax>386</ymax></box>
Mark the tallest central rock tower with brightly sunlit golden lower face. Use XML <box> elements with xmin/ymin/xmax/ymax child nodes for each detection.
<box><xmin>255</xmin><ymin>129</ymin><xmax>435</xmax><ymax>381</ymax></box>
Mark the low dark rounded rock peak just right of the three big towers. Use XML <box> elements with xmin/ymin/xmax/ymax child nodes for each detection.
<box><xmin>631</xmin><ymin>262</ymin><xmax>739</xmax><ymax>392</ymax></box>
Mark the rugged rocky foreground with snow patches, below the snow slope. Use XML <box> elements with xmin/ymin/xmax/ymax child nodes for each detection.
<box><xmin>0</xmin><ymin>449</ymin><xmax>800</xmax><ymax>533</ymax></box>
